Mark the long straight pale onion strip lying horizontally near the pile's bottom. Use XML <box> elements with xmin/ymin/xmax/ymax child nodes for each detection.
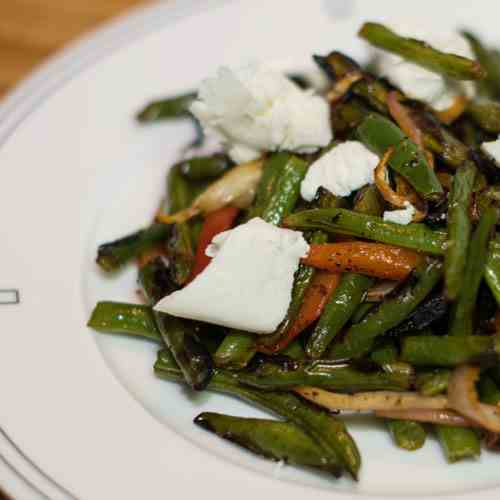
<box><xmin>295</xmin><ymin>386</ymin><xmax>448</xmax><ymax>411</ymax></box>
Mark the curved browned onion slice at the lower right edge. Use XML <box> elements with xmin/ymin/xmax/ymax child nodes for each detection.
<box><xmin>448</xmin><ymin>365</ymin><xmax>500</xmax><ymax>433</ymax></box>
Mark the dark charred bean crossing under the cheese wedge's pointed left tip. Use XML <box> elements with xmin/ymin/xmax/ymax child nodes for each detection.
<box><xmin>139</xmin><ymin>259</ymin><xmax>213</xmax><ymax>390</ymax></box>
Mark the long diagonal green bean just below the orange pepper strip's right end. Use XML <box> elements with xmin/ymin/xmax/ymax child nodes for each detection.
<box><xmin>328</xmin><ymin>259</ymin><xmax>442</xmax><ymax>361</ymax></box>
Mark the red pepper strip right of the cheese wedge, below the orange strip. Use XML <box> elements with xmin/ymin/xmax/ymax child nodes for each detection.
<box><xmin>258</xmin><ymin>271</ymin><xmax>340</xmax><ymax>354</ymax></box>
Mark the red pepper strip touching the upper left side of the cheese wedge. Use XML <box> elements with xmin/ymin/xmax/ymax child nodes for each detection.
<box><xmin>187</xmin><ymin>206</ymin><xmax>240</xmax><ymax>283</ymax></box>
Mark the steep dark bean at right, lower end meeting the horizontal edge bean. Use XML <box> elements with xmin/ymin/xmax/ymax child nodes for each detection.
<box><xmin>448</xmin><ymin>208</ymin><xmax>496</xmax><ymax>335</ymax></box>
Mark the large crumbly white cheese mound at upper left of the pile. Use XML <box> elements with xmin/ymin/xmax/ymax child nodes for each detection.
<box><xmin>190</xmin><ymin>63</ymin><xmax>332</xmax><ymax>163</ymax></box>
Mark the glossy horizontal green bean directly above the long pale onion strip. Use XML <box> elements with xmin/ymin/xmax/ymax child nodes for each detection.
<box><xmin>238</xmin><ymin>360</ymin><xmax>410</xmax><ymax>393</ymax></box>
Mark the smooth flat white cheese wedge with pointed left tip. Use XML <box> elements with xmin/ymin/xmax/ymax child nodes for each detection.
<box><xmin>155</xmin><ymin>218</ymin><xmax>309</xmax><ymax>333</ymax></box>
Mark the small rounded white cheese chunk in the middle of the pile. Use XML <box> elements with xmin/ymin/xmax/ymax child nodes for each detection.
<box><xmin>300</xmin><ymin>141</ymin><xmax>379</xmax><ymax>201</ymax></box>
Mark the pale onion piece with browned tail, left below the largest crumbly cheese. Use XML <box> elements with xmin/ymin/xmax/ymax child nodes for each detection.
<box><xmin>156</xmin><ymin>159</ymin><xmax>264</xmax><ymax>224</ymax></box>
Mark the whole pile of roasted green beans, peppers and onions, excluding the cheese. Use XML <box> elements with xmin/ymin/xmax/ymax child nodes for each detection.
<box><xmin>88</xmin><ymin>23</ymin><xmax>500</xmax><ymax>479</ymax></box>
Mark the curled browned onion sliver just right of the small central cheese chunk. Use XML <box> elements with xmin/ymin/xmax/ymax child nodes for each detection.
<box><xmin>374</xmin><ymin>147</ymin><xmax>427</xmax><ymax>222</ymax></box>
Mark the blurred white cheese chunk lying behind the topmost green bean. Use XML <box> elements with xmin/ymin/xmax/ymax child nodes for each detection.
<box><xmin>375</xmin><ymin>26</ymin><xmax>476</xmax><ymax>111</ymax></box>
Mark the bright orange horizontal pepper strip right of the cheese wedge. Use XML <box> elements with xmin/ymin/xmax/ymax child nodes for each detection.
<box><xmin>302</xmin><ymin>241</ymin><xmax>421</xmax><ymax>281</ymax></box>
